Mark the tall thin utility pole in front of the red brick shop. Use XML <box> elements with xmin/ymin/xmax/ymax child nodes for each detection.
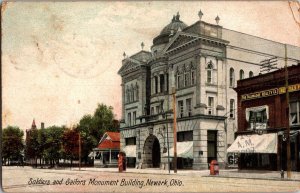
<box><xmin>284</xmin><ymin>44</ymin><xmax>292</xmax><ymax>178</ymax></box>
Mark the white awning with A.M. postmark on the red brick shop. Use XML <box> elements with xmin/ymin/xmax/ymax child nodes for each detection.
<box><xmin>227</xmin><ymin>133</ymin><xmax>277</xmax><ymax>153</ymax></box>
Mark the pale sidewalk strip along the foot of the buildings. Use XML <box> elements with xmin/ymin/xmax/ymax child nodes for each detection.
<box><xmin>74</xmin><ymin>168</ymin><xmax>300</xmax><ymax>181</ymax></box>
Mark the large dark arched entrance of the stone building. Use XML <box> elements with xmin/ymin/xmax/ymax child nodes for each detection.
<box><xmin>144</xmin><ymin>135</ymin><xmax>160</xmax><ymax>168</ymax></box>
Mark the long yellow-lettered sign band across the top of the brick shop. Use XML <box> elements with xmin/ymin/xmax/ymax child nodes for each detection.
<box><xmin>241</xmin><ymin>84</ymin><xmax>300</xmax><ymax>101</ymax></box>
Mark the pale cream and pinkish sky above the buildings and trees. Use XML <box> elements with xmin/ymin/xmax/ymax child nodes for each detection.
<box><xmin>1</xmin><ymin>1</ymin><xmax>300</xmax><ymax>130</ymax></box>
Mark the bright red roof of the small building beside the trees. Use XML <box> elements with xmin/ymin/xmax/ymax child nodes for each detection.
<box><xmin>97</xmin><ymin>132</ymin><xmax>120</xmax><ymax>150</ymax></box>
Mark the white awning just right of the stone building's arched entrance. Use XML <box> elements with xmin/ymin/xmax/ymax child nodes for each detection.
<box><xmin>163</xmin><ymin>141</ymin><xmax>193</xmax><ymax>159</ymax></box>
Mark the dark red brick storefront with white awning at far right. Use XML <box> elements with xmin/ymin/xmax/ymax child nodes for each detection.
<box><xmin>228</xmin><ymin>63</ymin><xmax>300</xmax><ymax>171</ymax></box>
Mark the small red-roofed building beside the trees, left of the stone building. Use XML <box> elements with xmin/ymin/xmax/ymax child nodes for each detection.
<box><xmin>89</xmin><ymin>132</ymin><xmax>120</xmax><ymax>167</ymax></box>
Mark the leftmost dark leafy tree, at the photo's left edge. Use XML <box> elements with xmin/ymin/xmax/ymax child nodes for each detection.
<box><xmin>2</xmin><ymin>126</ymin><xmax>24</xmax><ymax>165</ymax></box>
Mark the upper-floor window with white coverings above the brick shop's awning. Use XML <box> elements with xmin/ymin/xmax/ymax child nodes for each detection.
<box><xmin>246</xmin><ymin>105</ymin><xmax>269</xmax><ymax>129</ymax></box>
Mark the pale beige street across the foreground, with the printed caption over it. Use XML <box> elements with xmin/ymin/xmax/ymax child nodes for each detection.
<box><xmin>2</xmin><ymin>166</ymin><xmax>300</xmax><ymax>192</ymax></box>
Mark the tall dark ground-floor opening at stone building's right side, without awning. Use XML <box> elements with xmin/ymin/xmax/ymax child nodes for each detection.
<box><xmin>207</xmin><ymin>130</ymin><xmax>217</xmax><ymax>163</ymax></box>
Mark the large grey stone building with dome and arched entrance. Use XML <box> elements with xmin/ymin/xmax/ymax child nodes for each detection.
<box><xmin>118</xmin><ymin>11</ymin><xmax>300</xmax><ymax>169</ymax></box>
